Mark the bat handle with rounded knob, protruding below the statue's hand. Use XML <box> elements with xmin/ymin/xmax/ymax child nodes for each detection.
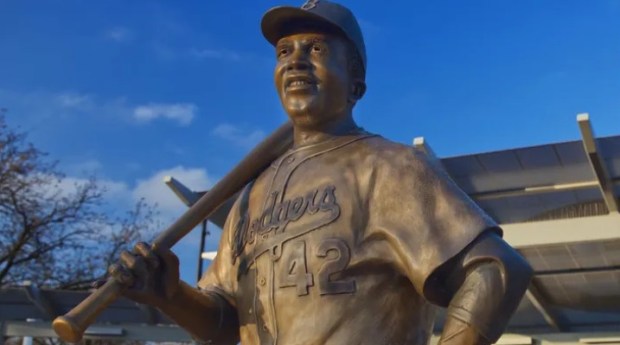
<box><xmin>52</xmin><ymin>279</ymin><xmax>124</xmax><ymax>343</ymax></box>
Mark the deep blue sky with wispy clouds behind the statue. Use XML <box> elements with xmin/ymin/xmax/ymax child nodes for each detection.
<box><xmin>0</xmin><ymin>0</ymin><xmax>620</xmax><ymax>282</ymax></box>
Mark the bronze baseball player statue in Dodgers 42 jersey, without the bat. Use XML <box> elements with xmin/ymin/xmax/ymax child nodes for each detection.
<box><xmin>110</xmin><ymin>0</ymin><xmax>532</xmax><ymax>345</ymax></box>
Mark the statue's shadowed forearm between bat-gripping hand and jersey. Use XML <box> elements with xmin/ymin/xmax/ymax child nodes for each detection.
<box><xmin>157</xmin><ymin>282</ymin><xmax>239</xmax><ymax>344</ymax></box>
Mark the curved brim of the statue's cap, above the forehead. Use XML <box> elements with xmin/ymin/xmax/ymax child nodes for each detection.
<box><xmin>261</xmin><ymin>6</ymin><xmax>340</xmax><ymax>46</ymax></box>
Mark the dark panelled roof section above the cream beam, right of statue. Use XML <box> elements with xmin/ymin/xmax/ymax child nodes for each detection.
<box><xmin>441</xmin><ymin>116</ymin><xmax>620</xmax><ymax>224</ymax></box>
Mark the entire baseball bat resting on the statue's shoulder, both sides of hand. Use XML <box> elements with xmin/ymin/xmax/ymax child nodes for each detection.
<box><xmin>52</xmin><ymin>122</ymin><xmax>293</xmax><ymax>342</ymax></box>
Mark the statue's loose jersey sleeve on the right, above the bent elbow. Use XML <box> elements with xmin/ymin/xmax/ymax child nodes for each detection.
<box><xmin>368</xmin><ymin>148</ymin><xmax>501</xmax><ymax>305</ymax></box>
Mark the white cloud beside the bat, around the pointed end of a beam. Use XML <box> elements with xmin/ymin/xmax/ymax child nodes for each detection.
<box><xmin>131</xmin><ymin>166</ymin><xmax>211</xmax><ymax>217</ymax></box>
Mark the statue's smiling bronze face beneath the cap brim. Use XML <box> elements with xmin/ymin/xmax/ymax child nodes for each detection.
<box><xmin>274</xmin><ymin>33</ymin><xmax>352</xmax><ymax>128</ymax></box>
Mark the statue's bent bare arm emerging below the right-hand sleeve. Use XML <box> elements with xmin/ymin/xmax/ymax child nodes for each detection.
<box><xmin>440</xmin><ymin>232</ymin><xmax>532</xmax><ymax>345</ymax></box>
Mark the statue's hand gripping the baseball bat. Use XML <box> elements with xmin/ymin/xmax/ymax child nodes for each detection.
<box><xmin>103</xmin><ymin>242</ymin><xmax>180</xmax><ymax>306</ymax></box>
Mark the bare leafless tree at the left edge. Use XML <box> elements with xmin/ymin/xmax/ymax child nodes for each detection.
<box><xmin>0</xmin><ymin>112</ymin><xmax>156</xmax><ymax>289</ymax></box>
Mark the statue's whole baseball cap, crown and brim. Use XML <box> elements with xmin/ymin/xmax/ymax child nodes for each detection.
<box><xmin>261</xmin><ymin>0</ymin><xmax>366</xmax><ymax>70</ymax></box>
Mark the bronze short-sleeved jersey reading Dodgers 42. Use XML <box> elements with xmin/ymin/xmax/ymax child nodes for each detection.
<box><xmin>199</xmin><ymin>132</ymin><xmax>497</xmax><ymax>345</ymax></box>
